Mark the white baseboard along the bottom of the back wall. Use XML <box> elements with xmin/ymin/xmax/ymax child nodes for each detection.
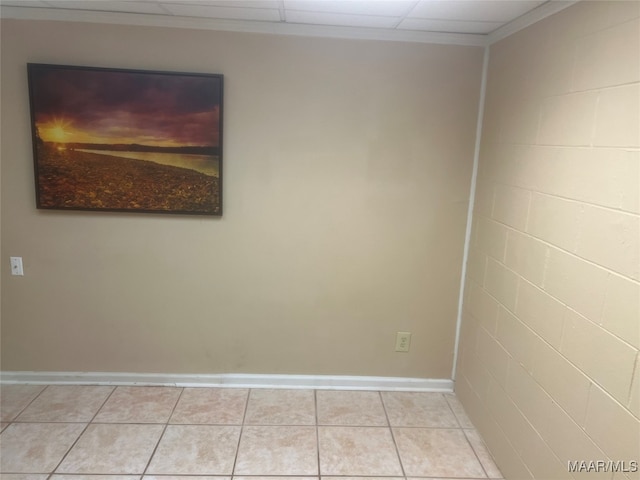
<box><xmin>0</xmin><ymin>372</ymin><xmax>453</xmax><ymax>392</ymax></box>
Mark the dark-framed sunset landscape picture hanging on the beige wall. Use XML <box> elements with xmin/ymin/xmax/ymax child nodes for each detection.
<box><xmin>28</xmin><ymin>64</ymin><xmax>223</xmax><ymax>215</ymax></box>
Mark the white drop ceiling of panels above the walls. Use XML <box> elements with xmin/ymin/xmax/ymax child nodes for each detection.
<box><xmin>0</xmin><ymin>0</ymin><xmax>569</xmax><ymax>44</ymax></box>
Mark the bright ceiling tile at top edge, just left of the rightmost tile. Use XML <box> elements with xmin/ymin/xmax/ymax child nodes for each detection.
<box><xmin>284</xmin><ymin>0</ymin><xmax>416</xmax><ymax>17</ymax></box>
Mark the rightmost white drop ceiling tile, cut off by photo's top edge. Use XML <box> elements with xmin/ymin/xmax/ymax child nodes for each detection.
<box><xmin>407</xmin><ymin>0</ymin><xmax>545</xmax><ymax>22</ymax></box>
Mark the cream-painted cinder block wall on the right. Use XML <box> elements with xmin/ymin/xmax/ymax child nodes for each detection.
<box><xmin>456</xmin><ymin>2</ymin><xmax>640</xmax><ymax>480</ymax></box>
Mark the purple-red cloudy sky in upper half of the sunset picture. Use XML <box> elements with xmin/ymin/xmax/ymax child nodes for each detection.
<box><xmin>30</xmin><ymin>67</ymin><xmax>221</xmax><ymax>146</ymax></box>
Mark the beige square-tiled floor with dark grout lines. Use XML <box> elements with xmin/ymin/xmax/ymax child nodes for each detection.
<box><xmin>0</xmin><ymin>385</ymin><xmax>502</xmax><ymax>480</ymax></box>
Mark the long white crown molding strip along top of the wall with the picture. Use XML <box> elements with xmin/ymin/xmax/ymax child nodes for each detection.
<box><xmin>0</xmin><ymin>6</ymin><xmax>486</xmax><ymax>46</ymax></box>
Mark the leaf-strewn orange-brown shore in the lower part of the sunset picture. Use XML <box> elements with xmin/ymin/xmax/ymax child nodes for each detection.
<box><xmin>37</xmin><ymin>144</ymin><xmax>221</xmax><ymax>215</ymax></box>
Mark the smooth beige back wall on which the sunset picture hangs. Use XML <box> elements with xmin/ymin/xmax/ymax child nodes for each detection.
<box><xmin>1</xmin><ymin>20</ymin><xmax>482</xmax><ymax>378</ymax></box>
